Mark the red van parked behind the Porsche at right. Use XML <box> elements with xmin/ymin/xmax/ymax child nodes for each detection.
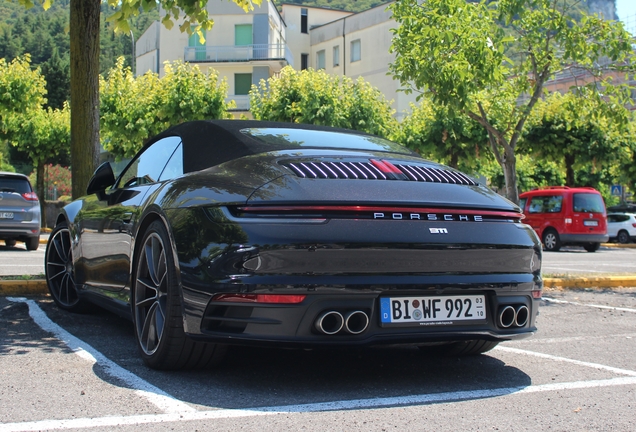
<box><xmin>519</xmin><ymin>186</ymin><xmax>609</xmax><ymax>252</ymax></box>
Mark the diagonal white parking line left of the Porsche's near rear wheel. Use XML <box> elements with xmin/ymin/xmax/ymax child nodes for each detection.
<box><xmin>7</xmin><ymin>297</ymin><xmax>196</xmax><ymax>416</ymax></box>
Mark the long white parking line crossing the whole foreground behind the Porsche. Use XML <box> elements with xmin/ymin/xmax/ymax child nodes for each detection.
<box><xmin>0</xmin><ymin>377</ymin><xmax>636</xmax><ymax>432</ymax></box>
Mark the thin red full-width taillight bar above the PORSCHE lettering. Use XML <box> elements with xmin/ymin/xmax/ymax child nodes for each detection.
<box><xmin>237</xmin><ymin>205</ymin><xmax>525</xmax><ymax>220</ymax></box>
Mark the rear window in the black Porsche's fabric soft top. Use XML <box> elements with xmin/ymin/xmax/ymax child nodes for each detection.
<box><xmin>241</xmin><ymin>128</ymin><xmax>413</xmax><ymax>155</ymax></box>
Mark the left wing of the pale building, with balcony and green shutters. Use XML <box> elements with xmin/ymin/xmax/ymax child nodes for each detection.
<box><xmin>135</xmin><ymin>0</ymin><xmax>294</xmax><ymax>111</ymax></box>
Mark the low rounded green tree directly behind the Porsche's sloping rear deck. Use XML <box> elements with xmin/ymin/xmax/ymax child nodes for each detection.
<box><xmin>393</xmin><ymin>98</ymin><xmax>488</xmax><ymax>172</ymax></box>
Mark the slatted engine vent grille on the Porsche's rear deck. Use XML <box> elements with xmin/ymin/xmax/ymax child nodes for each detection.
<box><xmin>281</xmin><ymin>161</ymin><xmax>477</xmax><ymax>186</ymax></box>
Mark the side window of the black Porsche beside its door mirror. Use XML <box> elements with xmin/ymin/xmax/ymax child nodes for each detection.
<box><xmin>117</xmin><ymin>136</ymin><xmax>183</xmax><ymax>188</ymax></box>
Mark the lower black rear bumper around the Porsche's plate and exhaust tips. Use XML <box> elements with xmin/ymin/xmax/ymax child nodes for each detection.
<box><xmin>184</xmin><ymin>283</ymin><xmax>539</xmax><ymax>348</ymax></box>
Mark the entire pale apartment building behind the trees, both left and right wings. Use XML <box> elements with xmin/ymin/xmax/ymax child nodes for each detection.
<box><xmin>135</xmin><ymin>0</ymin><xmax>415</xmax><ymax>117</ymax></box>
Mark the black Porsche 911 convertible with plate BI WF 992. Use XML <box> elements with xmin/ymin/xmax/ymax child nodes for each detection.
<box><xmin>45</xmin><ymin>120</ymin><xmax>543</xmax><ymax>369</ymax></box>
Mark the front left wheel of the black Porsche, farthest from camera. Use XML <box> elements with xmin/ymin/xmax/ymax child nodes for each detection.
<box><xmin>45</xmin><ymin>222</ymin><xmax>87</xmax><ymax>312</ymax></box>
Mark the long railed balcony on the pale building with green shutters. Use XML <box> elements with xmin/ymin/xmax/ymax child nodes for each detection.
<box><xmin>184</xmin><ymin>44</ymin><xmax>294</xmax><ymax>66</ymax></box>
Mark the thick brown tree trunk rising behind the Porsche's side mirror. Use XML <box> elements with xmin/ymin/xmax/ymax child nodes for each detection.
<box><xmin>70</xmin><ymin>0</ymin><xmax>101</xmax><ymax>198</ymax></box>
